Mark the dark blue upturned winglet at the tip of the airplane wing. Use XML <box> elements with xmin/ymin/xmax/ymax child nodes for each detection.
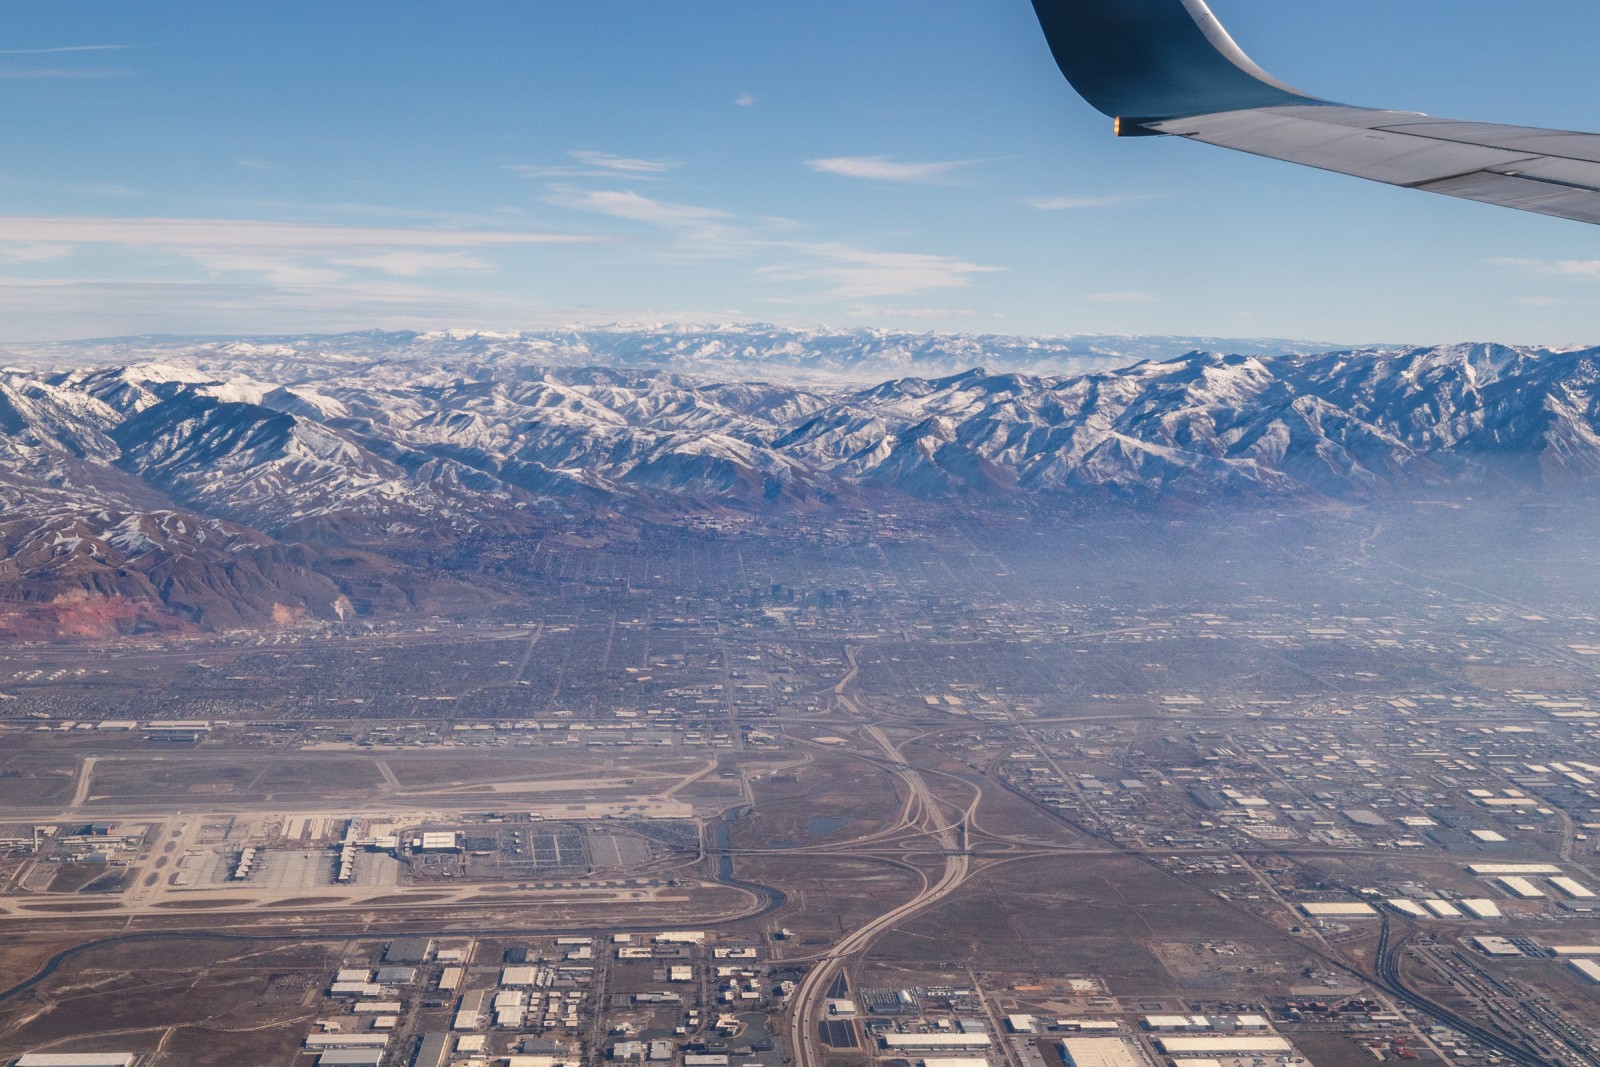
<box><xmin>1034</xmin><ymin>0</ymin><xmax>1331</xmax><ymax>125</ymax></box>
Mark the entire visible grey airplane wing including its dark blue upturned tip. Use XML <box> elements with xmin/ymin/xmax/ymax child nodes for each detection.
<box><xmin>1034</xmin><ymin>0</ymin><xmax>1600</xmax><ymax>222</ymax></box>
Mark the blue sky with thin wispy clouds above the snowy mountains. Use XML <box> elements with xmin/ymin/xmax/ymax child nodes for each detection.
<box><xmin>0</xmin><ymin>0</ymin><xmax>1600</xmax><ymax>344</ymax></box>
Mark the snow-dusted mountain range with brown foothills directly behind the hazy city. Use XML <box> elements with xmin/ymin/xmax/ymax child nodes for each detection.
<box><xmin>0</xmin><ymin>327</ymin><xmax>1600</xmax><ymax>637</ymax></box>
